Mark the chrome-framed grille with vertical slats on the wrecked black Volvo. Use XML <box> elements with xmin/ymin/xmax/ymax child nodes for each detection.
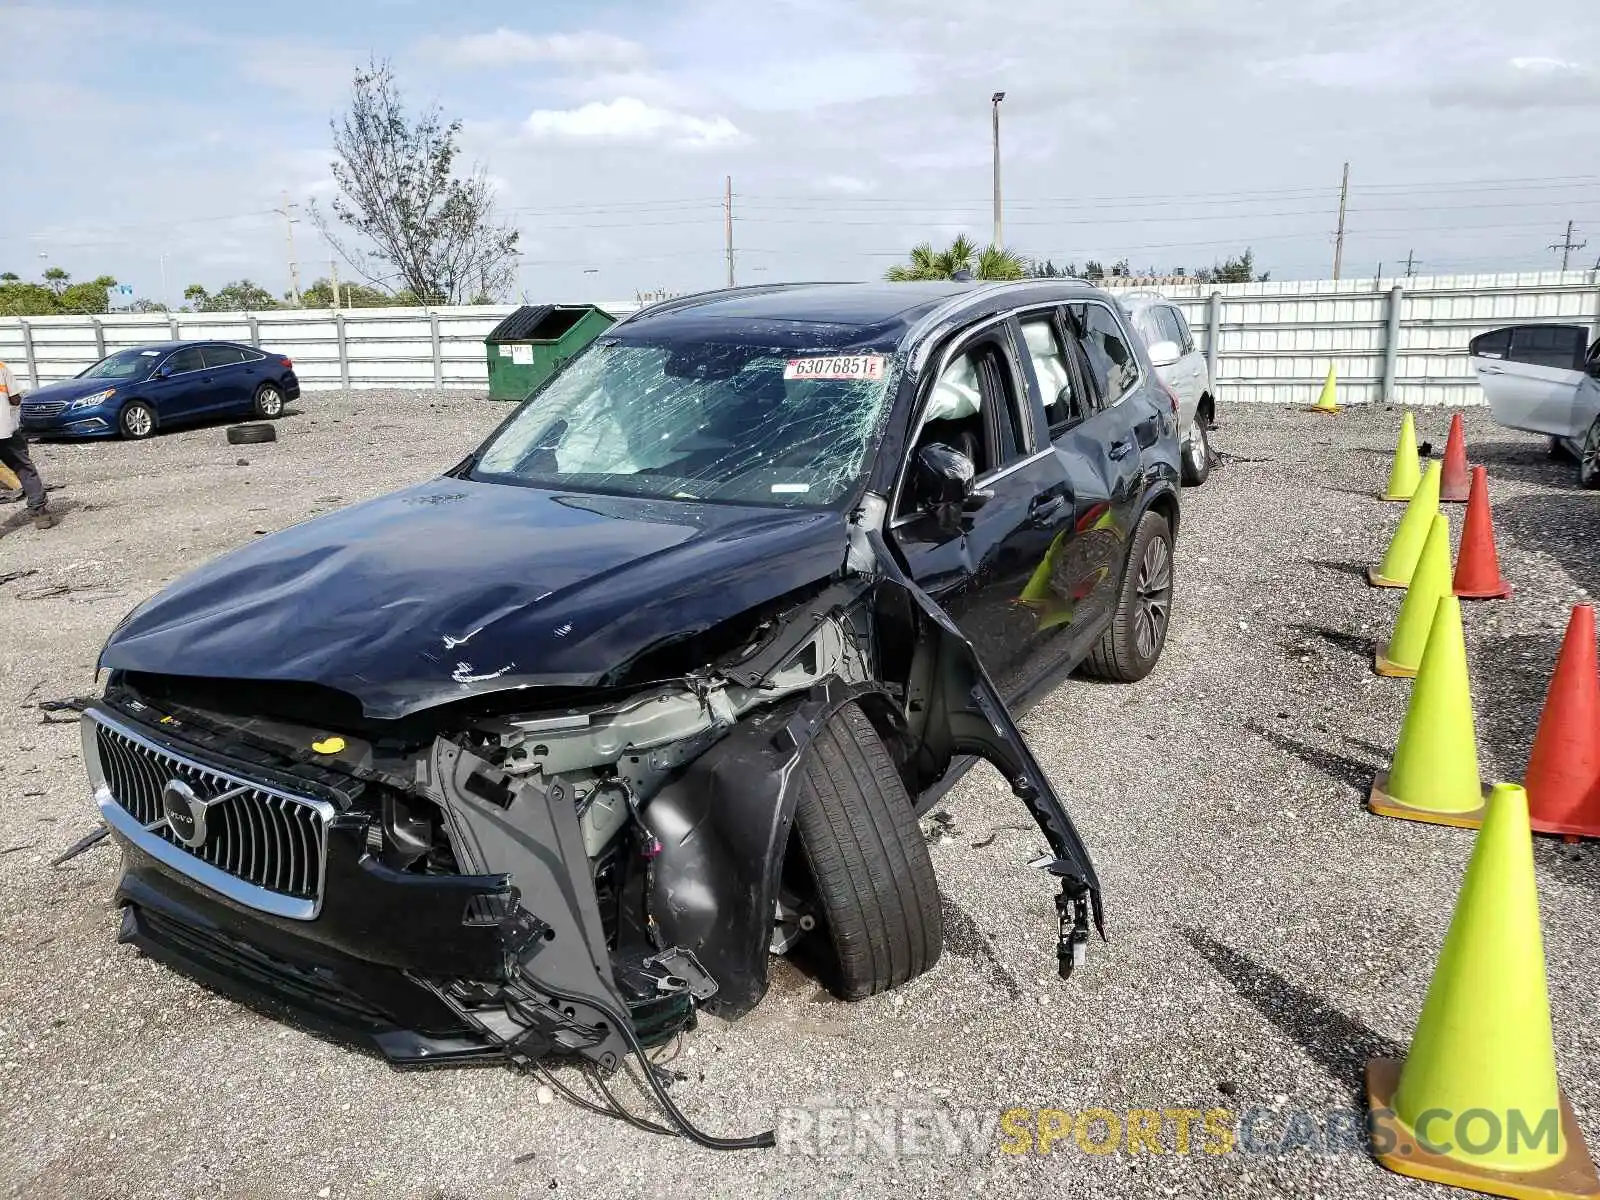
<box><xmin>83</xmin><ymin>710</ymin><xmax>334</xmax><ymax>920</ymax></box>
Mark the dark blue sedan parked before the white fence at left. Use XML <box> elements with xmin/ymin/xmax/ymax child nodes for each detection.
<box><xmin>22</xmin><ymin>342</ymin><xmax>299</xmax><ymax>438</ymax></box>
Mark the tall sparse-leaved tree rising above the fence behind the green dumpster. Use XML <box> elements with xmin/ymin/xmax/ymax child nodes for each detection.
<box><xmin>310</xmin><ymin>59</ymin><xmax>518</xmax><ymax>304</ymax></box>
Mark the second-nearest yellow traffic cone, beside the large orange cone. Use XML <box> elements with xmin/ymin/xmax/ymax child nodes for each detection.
<box><xmin>1366</xmin><ymin>592</ymin><xmax>1483</xmax><ymax>827</ymax></box>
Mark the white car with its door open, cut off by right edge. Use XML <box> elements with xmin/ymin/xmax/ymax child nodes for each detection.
<box><xmin>1469</xmin><ymin>325</ymin><xmax>1600</xmax><ymax>488</ymax></box>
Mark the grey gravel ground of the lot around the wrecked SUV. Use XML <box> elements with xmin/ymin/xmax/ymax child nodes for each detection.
<box><xmin>0</xmin><ymin>392</ymin><xmax>1600</xmax><ymax>1200</ymax></box>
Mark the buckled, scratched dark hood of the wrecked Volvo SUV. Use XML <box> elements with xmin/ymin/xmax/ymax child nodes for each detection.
<box><xmin>101</xmin><ymin>478</ymin><xmax>846</xmax><ymax>718</ymax></box>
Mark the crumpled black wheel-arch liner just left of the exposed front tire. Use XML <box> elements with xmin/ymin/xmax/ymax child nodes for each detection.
<box><xmin>645</xmin><ymin>678</ymin><xmax>899</xmax><ymax>1018</ymax></box>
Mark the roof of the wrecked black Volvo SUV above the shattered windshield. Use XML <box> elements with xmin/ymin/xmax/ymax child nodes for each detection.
<box><xmin>613</xmin><ymin>278</ymin><xmax>1120</xmax><ymax>346</ymax></box>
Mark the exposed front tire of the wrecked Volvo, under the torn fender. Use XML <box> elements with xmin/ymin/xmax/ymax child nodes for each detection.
<box><xmin>795</xmin><ymin>704</ymin><xmax>944</xmax><ymax>1000</ymax></box>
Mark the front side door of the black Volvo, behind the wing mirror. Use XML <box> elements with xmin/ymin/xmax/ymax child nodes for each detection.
<box><xmin>890</xmin><ymin>318</ymin><xmax>1075</xmax><ymax>701</ymax></box>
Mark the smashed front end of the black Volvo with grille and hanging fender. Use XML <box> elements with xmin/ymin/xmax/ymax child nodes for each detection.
<box><xmin>83</xmin><ymin>514</ymin><xmax>1104</xmax><ymax>1141</ymax></box>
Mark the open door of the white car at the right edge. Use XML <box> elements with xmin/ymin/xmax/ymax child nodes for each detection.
<box><xmin>1467</xmin><ymin>325</ymin><xmax>1592</xmax><ymax>438</ymax></box>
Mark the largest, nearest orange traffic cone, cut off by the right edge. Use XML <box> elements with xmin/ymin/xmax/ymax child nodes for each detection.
<box><xmin>1523</xmin><ymin>605</ymin><xmax>1600</xmax><ymax>837</ymax></box>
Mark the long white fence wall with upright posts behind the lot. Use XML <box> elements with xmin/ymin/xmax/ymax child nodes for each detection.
<box><xmin>0</xmin><ymin>270</ymin><xmax>1600</xmax><ymax>405</ymax></box>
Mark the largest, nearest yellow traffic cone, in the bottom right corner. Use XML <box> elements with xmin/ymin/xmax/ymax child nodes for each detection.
<box><xmin>1366</xmin><ymin>784</ymin><xmax>1600</xmax><ymax>1200</ymax></box>
